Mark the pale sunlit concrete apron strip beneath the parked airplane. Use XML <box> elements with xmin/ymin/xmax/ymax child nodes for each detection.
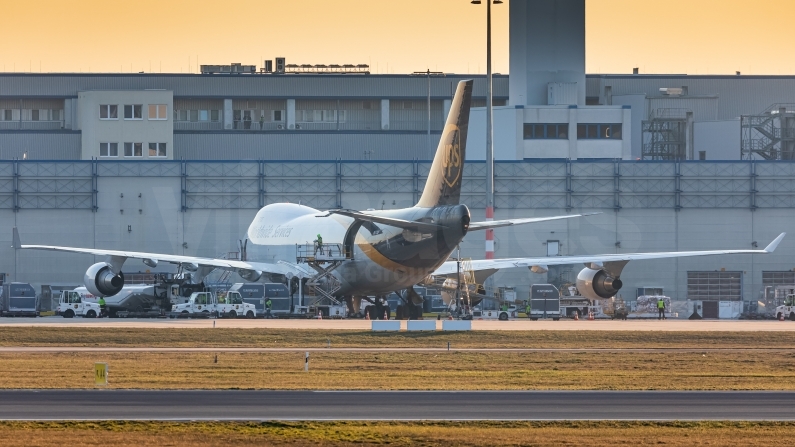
<box><xmin>0</xmin><ymin>317</ymin><xmax>795</xmax><ymax>332</ymax></box>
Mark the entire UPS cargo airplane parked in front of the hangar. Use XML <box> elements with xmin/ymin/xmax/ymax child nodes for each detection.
<box><xmin>13</xmin><ymin>80</ymin><xmax>785</xmax><ymax>309</ymax></box>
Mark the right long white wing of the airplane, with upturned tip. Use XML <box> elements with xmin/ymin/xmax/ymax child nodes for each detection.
<box><xmin>433</xmin><ymin>233</ymin><xmax>787</xmax><ymax>275</ymax></box>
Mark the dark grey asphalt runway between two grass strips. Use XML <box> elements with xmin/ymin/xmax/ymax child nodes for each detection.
<box><xmin>0</xmin><ymin>390</ymin><xmax>795</xmax><ymax>421</ymax></box>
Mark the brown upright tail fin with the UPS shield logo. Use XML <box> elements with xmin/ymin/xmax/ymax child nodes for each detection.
<box><xmin>417</xmin><ymin>79</ymin><xmax>472</xmax><ymax>208</ymax></box>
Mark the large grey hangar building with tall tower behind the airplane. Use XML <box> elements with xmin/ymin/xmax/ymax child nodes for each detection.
<box><xmin>0</xmin><ymin>0</ymin><xmax>795</xmax><ymax>312</ymax></box>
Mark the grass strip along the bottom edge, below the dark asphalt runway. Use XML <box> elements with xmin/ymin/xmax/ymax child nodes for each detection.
<box><xmin>0</xmin><ymin>422</ymin><xmax>795</xmax><ymax>447</ymax></box>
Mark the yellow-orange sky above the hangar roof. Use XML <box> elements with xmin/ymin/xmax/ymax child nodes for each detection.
<box><xmin>0</xmin><ymin>0</ymin><xmax>795</xmax><ymax>74</ymax></box>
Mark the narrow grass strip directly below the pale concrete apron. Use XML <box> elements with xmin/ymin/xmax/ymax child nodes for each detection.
<box><xmin>0</xmin><ymin>327</ymin><xmax>793</xmax><ymax>349</ymax></box>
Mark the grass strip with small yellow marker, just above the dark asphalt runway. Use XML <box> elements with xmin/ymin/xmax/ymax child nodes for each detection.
<box><xmin>0</xmin><ymin>351</ymin><xmax>795</xmax><ymax>390</ymax></box>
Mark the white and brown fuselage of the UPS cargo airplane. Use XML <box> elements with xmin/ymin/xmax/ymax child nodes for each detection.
<box><xmin>247</xmin><ymin>203</ymin><xmax>469</xmax><ymax>296</ymax></box>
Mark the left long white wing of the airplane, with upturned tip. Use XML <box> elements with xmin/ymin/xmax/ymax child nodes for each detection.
<box><xmin>13</xmin><ymin>227</ymin><xmax>313</xmax><ymax>277</ymax></box>
